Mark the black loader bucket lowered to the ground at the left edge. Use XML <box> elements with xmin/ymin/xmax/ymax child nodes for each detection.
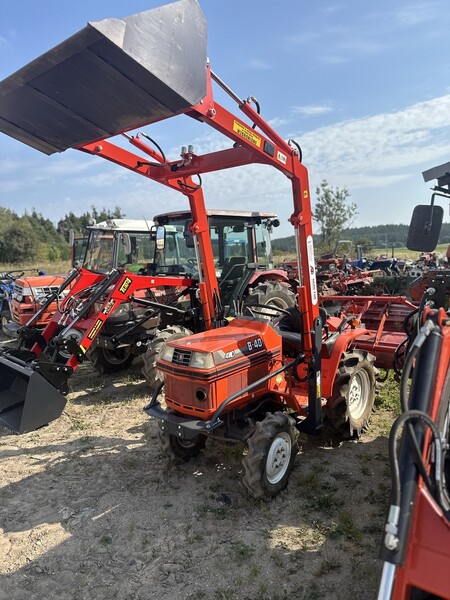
<box><xmin>0</xmin><ymin>356</ymin><xmax>67</xmax><ymax>433</ymax></box>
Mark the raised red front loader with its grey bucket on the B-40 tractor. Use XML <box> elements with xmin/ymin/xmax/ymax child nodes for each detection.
<box><xmin>0</xmin><ymin>0</ymin><xmax>322</xmax><ymax>429</ymax></box>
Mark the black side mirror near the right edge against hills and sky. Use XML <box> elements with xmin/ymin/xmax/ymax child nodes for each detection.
<box><xmin>406</xmin><ymin>204</ymin><xmax>444</xmax><ymax>252</ymax></box>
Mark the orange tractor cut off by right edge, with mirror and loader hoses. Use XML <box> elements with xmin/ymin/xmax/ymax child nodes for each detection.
<box><xmin>378</xmin><ymin>163</ymin><xmax>450</xmax><ymax>600</ymax></box>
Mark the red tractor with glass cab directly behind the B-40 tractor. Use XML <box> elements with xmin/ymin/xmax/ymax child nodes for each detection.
<box><xmin>143</xmin><ymin>209</ymin><xmax>297</xmax><ymax>388</ymax></box>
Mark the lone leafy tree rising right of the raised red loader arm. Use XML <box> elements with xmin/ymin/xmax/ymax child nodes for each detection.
<box><xmin>313</xmin><ymin>179</ymin><xmax>358</xmax><ymax>251</ymax></box>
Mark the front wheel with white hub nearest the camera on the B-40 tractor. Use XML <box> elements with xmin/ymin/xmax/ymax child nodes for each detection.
<box><xmin>242</xmin><ymin>411</ymin><xmax>299</xmax><ymax>500</ymax></box>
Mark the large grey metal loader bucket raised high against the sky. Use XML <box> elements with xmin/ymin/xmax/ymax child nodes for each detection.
<box><xmin>0</xmin><ymin>0</ymin><xmax>207</xmax><ymax>154</ymax></box>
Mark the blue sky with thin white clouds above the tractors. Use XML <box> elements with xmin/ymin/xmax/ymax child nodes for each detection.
<box><xmin>0</xmin><ymin>0</ymin><xmax>450</xmax><ymax>237</ymax></box>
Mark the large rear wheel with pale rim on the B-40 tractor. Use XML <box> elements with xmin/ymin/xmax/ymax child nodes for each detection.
<box><xmin>325</xmin><ymin>350</ymin><xmax>378</xmax><ymax>439</ymax></box>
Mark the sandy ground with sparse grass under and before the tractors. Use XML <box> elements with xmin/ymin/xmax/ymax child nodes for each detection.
<box><xmin>0</xmin><ymin>359</ymin><xmax>393</xmax><ymax>600</ymax></box>
